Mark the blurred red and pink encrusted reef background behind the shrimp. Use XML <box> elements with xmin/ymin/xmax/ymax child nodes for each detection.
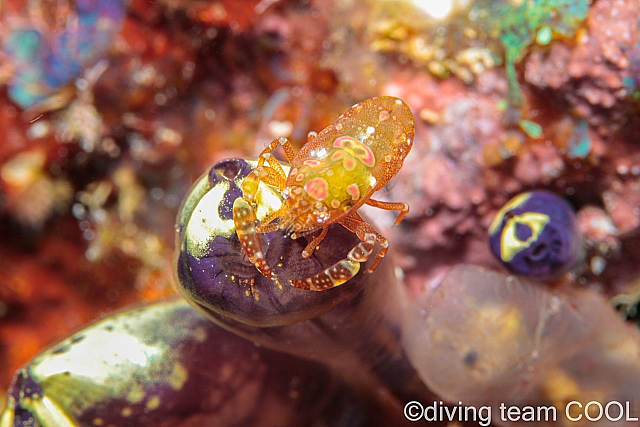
<box><xmin>0</xmin><ymin>0</ymin><xmax>640</xmax><ymax>416</ymax></box>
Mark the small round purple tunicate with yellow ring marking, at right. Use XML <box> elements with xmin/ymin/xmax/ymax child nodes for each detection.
<box><xmin>489</xmin><ymin>191</ymin><xmax>584</xmax><ymax>279</ymax></box>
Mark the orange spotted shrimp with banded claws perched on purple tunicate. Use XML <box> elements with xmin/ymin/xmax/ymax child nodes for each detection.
<box><xmin>234</xmin><ymin>96</ymin><xmax>414</xmax><ymax>290</ymax></box>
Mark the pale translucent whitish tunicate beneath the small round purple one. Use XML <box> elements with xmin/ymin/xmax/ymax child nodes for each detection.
<box><xmin>403</xmin><ymin>265</ymin><xmax>640</xmax><ymax>426</ymax></box>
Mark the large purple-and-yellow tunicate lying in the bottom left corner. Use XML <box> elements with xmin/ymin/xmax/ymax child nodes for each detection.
<box><xmin>0</xmin><ymin>300</ymin><xmax>406</xmax><ymax>427</ymax></box>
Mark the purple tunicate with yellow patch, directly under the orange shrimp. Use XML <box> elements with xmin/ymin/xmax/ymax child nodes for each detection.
<box><xmin>176</xmin><ymin>159</ymin><xmax>430</xmax><ymax>401</ymax></box>
